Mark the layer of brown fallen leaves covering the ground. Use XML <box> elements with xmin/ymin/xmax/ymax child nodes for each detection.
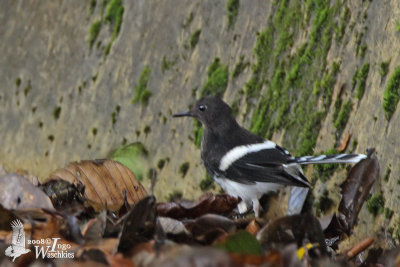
<box><xmin>0</xmin><ymin>152</ymin><xmax>394</xmax><ymax>267</ymax></box>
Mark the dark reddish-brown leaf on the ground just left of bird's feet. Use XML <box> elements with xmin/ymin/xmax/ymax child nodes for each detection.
<box><xmin>157</xmin><ymin>193</ymin><xmax>240</xmax><ymax>219</ymax></box>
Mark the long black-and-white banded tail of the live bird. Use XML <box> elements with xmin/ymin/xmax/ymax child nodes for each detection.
<box><xmin>295</xmin><ymin>154</ymin><xmax>367</xmax><ymax>165</ymax></box>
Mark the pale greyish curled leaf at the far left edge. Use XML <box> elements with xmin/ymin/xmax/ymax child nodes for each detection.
<box><xmin>0</xmin><ymin>174</ymin><xmax>54</xmax><ymax>213</ymax></box>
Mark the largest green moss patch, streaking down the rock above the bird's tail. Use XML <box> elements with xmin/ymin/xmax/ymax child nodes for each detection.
<box><xmin>245</xmin><ymin>0</ymin><xmax>343</xmax><ymax>155</ymax></box>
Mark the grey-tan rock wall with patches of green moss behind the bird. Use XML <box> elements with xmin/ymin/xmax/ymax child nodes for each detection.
<box><xmin>0</xmin><ymin>0</ymin><xmax>400</xmax><ymax>247</ymax></box>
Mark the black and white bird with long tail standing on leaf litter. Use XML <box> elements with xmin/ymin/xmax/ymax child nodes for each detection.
<box><xmin>173</xmin><ymin>96</ymin><xmax>367</xmax><ymax>217</ymax></box>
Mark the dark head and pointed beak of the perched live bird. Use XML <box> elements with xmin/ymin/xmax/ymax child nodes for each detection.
<box><xmin>173</xmin><ymin>96</ymin><xmax>235</xmax><ymax>128</ymax></box>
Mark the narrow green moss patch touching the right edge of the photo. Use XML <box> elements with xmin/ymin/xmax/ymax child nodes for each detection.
<box><xmin>383</xmin><ymin>66</ymin><xmax>400</xmax><ymax>120</ymax></box>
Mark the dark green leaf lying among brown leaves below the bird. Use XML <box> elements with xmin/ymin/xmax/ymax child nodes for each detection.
<box><xmin>217</xmin><ymin>230</ymin><xmax>261</xmax><ymax>255</ymax></box>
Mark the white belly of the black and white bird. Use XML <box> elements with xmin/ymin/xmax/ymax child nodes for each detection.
<box><xmin>214</xmin><ymin>176</ymin><xmax>282</xmax><ymax>205</ymax></box>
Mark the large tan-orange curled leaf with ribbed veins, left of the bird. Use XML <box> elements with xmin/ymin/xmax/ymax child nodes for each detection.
<box><xmin>48</xmin><ymin>159</ymin><xmax>147</xmax><ymax>213</ymax></box>
